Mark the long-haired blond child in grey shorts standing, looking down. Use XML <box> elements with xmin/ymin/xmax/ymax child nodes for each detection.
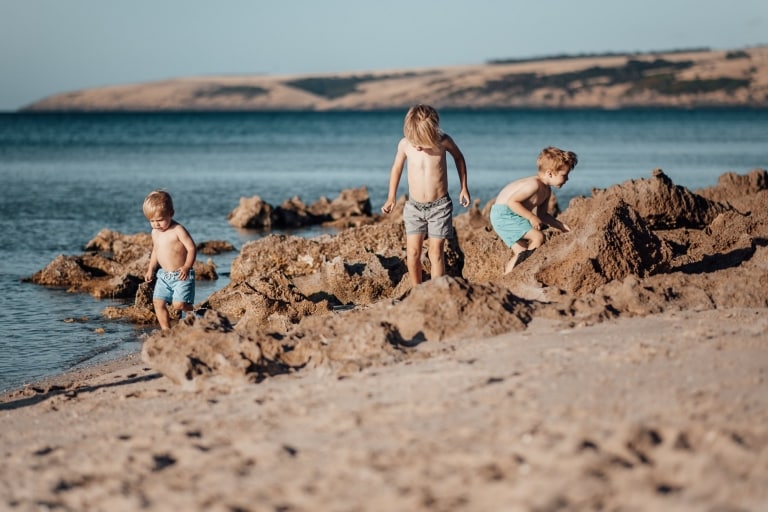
<box><xmin>381</xmin><ymin>105</ymin><xmax>469</xmax><ymax>285</ymax></box>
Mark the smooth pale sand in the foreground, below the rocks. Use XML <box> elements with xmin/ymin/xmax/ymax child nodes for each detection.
<box><xmin>0</xmin><ymin>308</ymin><xmax>768</xmax><ymax>511</ymax></box>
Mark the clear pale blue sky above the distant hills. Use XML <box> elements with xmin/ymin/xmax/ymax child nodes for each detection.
<box><xmin>0</xmin><ymin>0</ymin><xmax>768</xmax><ymax>111</ymax></box>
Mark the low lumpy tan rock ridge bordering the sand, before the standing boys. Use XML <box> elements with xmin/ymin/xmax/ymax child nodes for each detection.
<box><xmin>147</xmin><ymin>276</ymin><xmax>532</xmax><ymax>389</ymax></box>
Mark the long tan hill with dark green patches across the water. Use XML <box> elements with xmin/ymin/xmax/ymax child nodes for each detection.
<box><xmin>22</xmin><ymin>46</ymin><xmax>768</xmax><ymax>112</ymax></box>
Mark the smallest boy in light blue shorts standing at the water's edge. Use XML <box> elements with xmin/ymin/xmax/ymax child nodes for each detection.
<box><xmin>144</xmin><ymin>190</ymin><xmax>197</xmax><ymax>330</ymax></box>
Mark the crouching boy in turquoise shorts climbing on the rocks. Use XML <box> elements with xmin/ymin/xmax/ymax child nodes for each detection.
<box><xmin>491</xmin><ymin>146</ymin><xmax>578</xmax><ymax>275</ymax></box>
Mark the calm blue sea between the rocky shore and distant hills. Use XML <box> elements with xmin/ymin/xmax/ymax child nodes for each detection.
<box><xmin>0</xmin><ymin>109</ymin><xmax>768</xmax><ymax>391</ymax></box>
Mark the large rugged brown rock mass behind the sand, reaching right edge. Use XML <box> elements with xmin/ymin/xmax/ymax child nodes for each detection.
<box><xmin>143</xmin><ymin>170</ymin><xmax>768</xmax><ymax>389</ymax></box>
